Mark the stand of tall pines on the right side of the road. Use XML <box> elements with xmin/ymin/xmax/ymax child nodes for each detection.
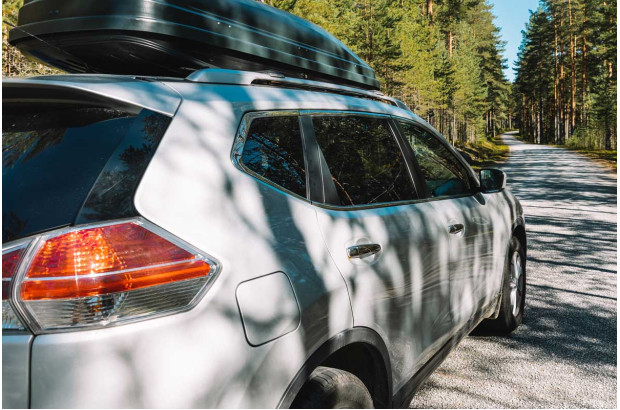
<box><xmin>513</xmin><ymin>0</ymin><xmax>617</xmax><ymax>149</ymax></box>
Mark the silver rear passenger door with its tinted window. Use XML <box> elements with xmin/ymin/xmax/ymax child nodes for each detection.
<box><xmin>302</xmin><ymin>112</ymin><xmax>451</xmax><ymax>391</ymax></box>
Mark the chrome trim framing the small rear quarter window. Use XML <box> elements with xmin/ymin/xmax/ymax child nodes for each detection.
<box><xmin>230</xmin><ymin>110</ymin><xmax>312</xmax><ymax>203</ymax></box>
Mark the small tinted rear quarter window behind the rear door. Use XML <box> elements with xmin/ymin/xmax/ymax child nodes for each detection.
<box><xmin>241</xmin><ymin>116</ymin><xmax>306</xmax><ymax>198</ymax></box>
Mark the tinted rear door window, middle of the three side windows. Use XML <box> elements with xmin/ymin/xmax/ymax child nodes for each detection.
<box><xmin>312</xmin><ymin>115</ymin><xmax>416</xmax><ymax>205</ymax></box>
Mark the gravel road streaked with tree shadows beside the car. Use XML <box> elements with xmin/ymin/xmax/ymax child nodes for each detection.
<box><xmin>411</xmin><ymin>134</ymin><xmax>618</xmax><ymax>408</ymax></box>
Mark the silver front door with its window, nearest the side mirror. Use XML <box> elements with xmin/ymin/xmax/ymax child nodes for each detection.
<box><xmin>397</xmin><ymin>120</ymin><xmax>499</xmax><ymax>328</ymax></box>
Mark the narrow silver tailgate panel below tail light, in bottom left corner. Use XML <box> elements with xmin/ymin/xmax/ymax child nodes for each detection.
<box><xmin>2</xmin><ymin>333</ymin><xmax>33</xmax><ymax>409</ymax></box>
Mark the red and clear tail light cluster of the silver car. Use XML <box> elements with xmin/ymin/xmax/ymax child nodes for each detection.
<box><xmin>3</xmin><ymin>220</ymin><xmax>217</xmax><ymax>330</ymax></box>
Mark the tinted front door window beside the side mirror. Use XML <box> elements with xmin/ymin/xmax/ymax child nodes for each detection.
<box><xmin>399</xmin><ymin>121</ymin><xmax>470</xmax><ymax>197</ymax></box>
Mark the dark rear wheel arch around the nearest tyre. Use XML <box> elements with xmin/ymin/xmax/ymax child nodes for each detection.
<box><xmin>278</xmin><ymin>327</ymin><xmax>392</xmax><ymax>408</ymax></box>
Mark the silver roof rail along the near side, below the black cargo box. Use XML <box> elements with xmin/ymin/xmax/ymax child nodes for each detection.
<box><xmin>185</xmin><ymin>68</ymin><xmax>399</xmax><ymax>107</ymax></box>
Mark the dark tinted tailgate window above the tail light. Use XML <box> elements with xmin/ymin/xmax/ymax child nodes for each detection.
<box><xmin>2</xmin><ymin>106</ymin><xmax>168</xmax><ymax>242</ymax></box>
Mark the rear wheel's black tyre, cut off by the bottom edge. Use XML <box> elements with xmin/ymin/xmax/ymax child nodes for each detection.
<box><xmin>291</xmin><ymin>367</ymin><xmax>374</xmax><ymax>409</ymax></box>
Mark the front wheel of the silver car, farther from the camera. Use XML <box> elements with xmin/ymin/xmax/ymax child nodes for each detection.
<box><xmin>482</xmin><ymin>236</ymin><xmax>526</xmax><ymax>334</ymax></box>
